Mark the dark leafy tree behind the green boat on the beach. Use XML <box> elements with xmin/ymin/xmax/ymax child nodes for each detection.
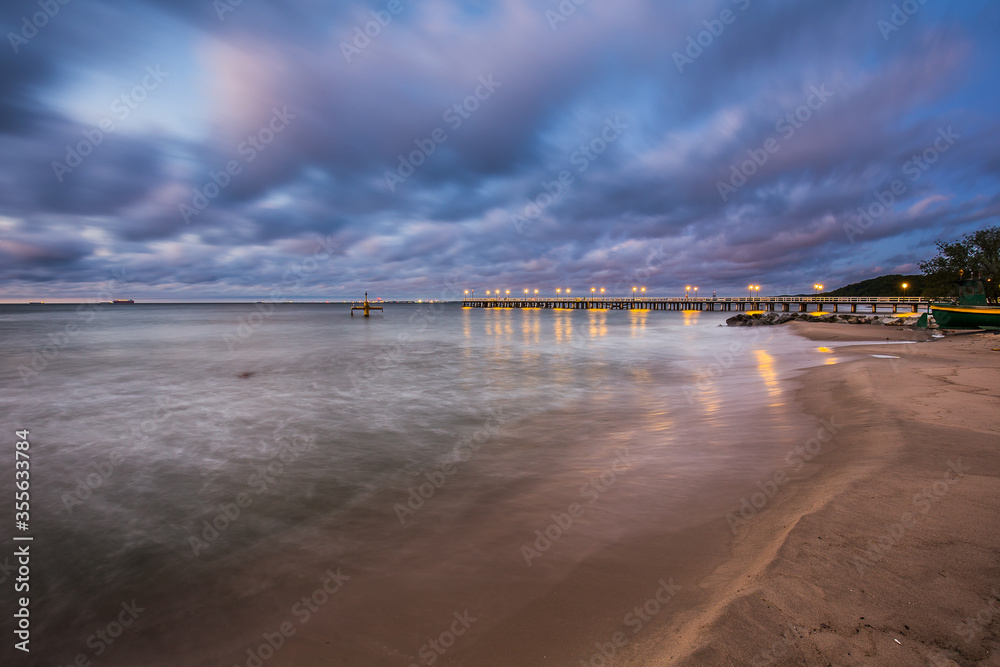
<box><xmin>920</xmin><ymin>227</ymin><xmax>1000</xmax><ymax>303</ymax></box>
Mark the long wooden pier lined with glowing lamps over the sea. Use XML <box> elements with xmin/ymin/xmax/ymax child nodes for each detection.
<box><xmin>462</xmin><ymin>296</ymin><xmax>930</xmax><ymax>313</ymax></box>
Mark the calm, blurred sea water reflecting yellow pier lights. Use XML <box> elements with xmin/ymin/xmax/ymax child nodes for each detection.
<box><xmin>0</xmin><ymin>305</ymin><xmax>836</xmax><ymax>667</ymax></box>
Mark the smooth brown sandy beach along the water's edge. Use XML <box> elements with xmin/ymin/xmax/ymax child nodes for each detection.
<box><xmin>624</xmin><ymin>323</ymin><xmax>1000</xmax><ymax>665</ymax></box>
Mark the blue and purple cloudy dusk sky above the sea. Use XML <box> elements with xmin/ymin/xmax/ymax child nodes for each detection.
<box><xmin>0</xmin><ymin>0</ymin><xmax>1000</xmax><ymax>301</ymax></box>
